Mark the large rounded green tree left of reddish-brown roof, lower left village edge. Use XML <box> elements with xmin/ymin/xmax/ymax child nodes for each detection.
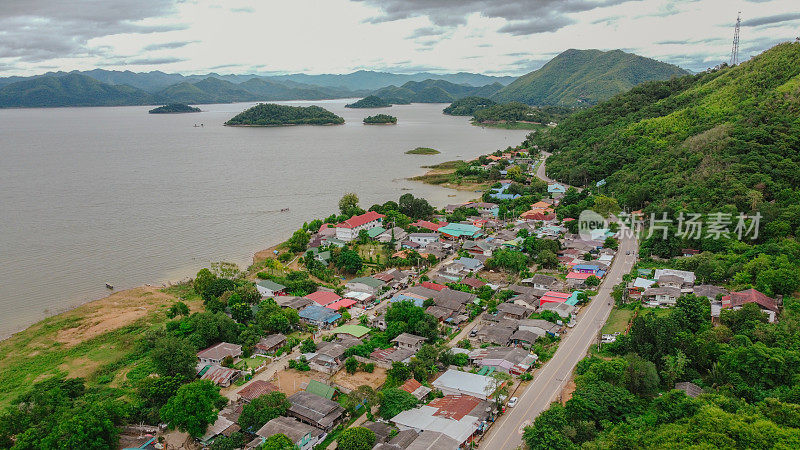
<box><xmin>161</xmin><ymin>380</ymin><xmax>228</xmax><ymax>437</ymax></box>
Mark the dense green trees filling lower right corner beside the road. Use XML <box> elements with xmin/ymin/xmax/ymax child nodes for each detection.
<box><xmin>524</xmin><ymin>296</ymin><xmax>800</xmax><ymax>449</ymax></box>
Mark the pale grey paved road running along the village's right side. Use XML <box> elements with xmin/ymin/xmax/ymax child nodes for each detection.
<box><xmin>480</xmin><ymin>150</ymin><xmax>636</xmax><ymax>450</ymax></box>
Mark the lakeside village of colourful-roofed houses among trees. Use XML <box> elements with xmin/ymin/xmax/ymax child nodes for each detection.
<box><xmin>122</xmin><ymin>150</ymin><xmax>780</xmax><ymax>450</ymax></box>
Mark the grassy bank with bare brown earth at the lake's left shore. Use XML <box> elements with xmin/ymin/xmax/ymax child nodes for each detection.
<box><xmin>0</xmin><ymin>286</ymin><xmax>202</xmax><ymax>407</ymax></box>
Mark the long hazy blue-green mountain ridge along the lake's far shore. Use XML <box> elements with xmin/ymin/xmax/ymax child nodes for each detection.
<box><xmin>0</xmin><ymin>69</ymin><xmax>513</xmax><ymax>107</ymax></box>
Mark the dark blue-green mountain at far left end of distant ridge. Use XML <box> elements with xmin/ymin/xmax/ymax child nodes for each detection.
<box><xmin>0</xmin><ymin>74</ymin><xmax>154</xmax><ymax>108</ymax></box>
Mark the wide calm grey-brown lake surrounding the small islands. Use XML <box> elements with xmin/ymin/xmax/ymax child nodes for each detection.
<box><xmin>0</xmin><ymin>99</ymin><xmax>527</xmax><ymax>337</ymax></box>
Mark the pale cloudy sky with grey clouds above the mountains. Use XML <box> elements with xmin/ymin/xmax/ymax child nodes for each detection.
<box><xmin>0</xmin><ymin>0</ymin><xmax>800</xmax><ymax>76</ymax></box>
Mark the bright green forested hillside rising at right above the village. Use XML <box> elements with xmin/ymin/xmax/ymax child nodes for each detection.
<box><xmin>537</xmin><ymin>43</ymin><xmax>800</xmax><ymax>210</ymax></box>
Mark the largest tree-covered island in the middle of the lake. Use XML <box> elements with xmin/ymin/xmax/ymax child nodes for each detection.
<box><xmin>225</xmin><ymin>103</ymin><xmax>344</xmax><ymax>127</ymax></box>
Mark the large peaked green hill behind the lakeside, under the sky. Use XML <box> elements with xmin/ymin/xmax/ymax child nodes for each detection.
<box><xmin>491</xmin><ymin>49</ymin><xmax>688</xmax><ymax>106</ymax></box>
